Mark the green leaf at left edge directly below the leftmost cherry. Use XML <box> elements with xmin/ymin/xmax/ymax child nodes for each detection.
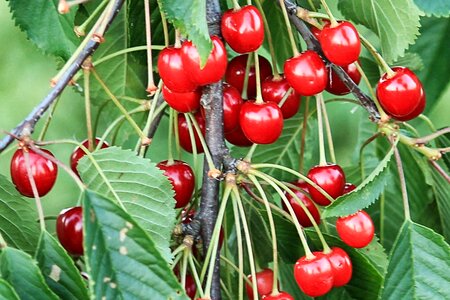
<box><xmin>0</xmin><ymin>174</ymin><xmax>39</xmax><ymax>254</ymax></box>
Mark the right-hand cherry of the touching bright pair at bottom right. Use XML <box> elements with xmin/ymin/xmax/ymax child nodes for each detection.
<box><xmin>326</xmin><ymin>247</ymin><xmax>353</xmax><ymax>287</ymax></box>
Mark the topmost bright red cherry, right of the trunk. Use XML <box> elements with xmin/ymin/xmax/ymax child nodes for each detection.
<box><xmin>221</xmin><ymin>5</ymin><xmax>264</xmax><ymax>53</ymax></box>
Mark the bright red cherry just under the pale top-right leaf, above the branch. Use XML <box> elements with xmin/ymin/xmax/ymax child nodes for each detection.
<box><xmin>319</xmin><ymin>21</ymin><xmax>361</xmax><ymax>66</ymax></box>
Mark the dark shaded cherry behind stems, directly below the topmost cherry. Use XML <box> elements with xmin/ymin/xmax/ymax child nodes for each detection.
<box><xmin>225</xmin><ymin>54</ymin><xmax>272</xmax><ymax>99</ymax></box>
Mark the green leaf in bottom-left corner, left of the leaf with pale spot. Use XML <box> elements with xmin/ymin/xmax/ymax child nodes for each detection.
<box><xmin>0</xmin><ymin>247</ymin><xmax>58</xmax><ymax>300</ymax></box>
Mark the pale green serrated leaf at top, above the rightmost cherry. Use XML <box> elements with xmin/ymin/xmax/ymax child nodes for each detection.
<box><xmin>338</xmin><ymin>0</ymin><xmax>421</xmax><ymax>63</ymax></box>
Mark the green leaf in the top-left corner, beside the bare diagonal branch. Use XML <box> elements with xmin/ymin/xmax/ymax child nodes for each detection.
<box><xmin>9</xmin><ymin>0</ymin><xmax>79</xmax><ymax>60</ymax></box>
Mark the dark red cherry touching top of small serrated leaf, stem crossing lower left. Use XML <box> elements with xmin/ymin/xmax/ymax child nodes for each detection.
<box><xmin>308</xmin><ymin>164</ymin><xmax>345</xmax><ymax>205</ymax></box>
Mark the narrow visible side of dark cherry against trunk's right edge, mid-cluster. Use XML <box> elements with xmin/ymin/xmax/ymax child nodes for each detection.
<box><xmin>223</xmin><ymin>83</ymin><xmax>244</xmax><ymax>133</ymax></box>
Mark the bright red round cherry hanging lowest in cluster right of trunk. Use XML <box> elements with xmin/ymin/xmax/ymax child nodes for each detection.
<box><xmin>239</xmin><ymin>101</ymin><xmax>283</xmax><ymax>144</ymax></box>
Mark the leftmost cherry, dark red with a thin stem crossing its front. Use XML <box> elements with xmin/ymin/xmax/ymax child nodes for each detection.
<box><xmin>10</xmin><ymin>148</ymin><xmax>58</xmax><ymax>198</ymax></box>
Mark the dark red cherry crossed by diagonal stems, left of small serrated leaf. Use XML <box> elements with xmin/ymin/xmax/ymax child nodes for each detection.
<box><xmin>282</xmin><ymin>182</ymin><xmax>320</xmax><ymax>227</ymax></box>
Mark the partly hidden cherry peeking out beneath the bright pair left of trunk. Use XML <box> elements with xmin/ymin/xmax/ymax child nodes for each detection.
<box><xmin>162</xmin><ymin>85</ymin><xmax>202</xmax><ymax>113</ymax></box>
